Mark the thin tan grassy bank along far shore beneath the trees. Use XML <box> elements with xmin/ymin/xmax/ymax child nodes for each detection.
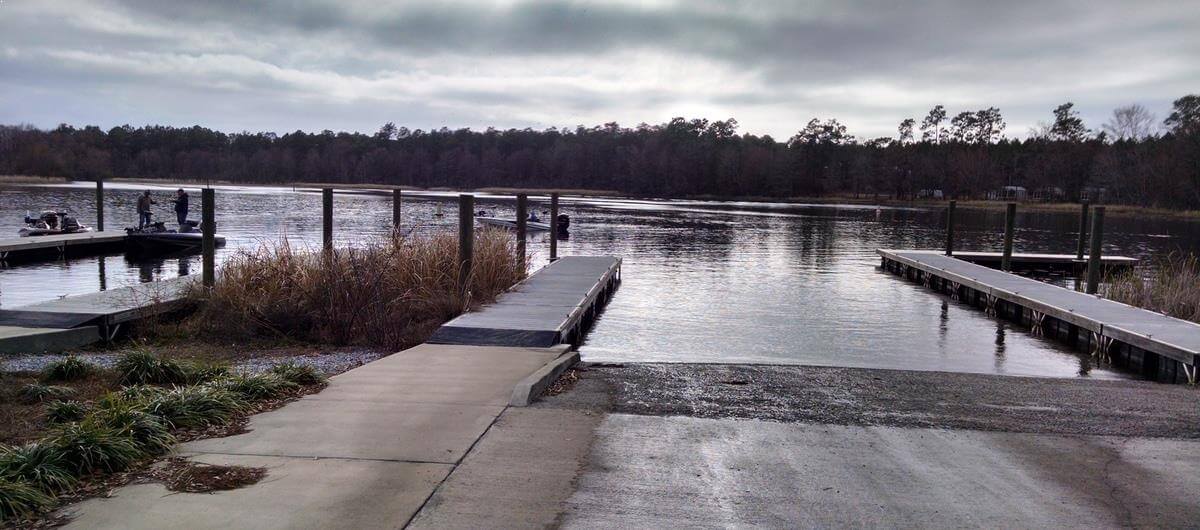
<box><xmin>0</xmin><ymin>175</ymin><xmax>1200</xmax><ymax>219</ymax></box>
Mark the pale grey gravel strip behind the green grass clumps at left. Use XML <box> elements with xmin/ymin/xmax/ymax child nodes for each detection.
<box><xmin>0</xmin><ymin>350</ymin><xmax>389</xmax><ymax>375</ymax></box>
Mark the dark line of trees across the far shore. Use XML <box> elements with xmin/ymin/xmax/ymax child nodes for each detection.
<box><xmin>0</xmin><ymin>95</ymin><xmax>1200</xmax><ymax>209</ymax></box>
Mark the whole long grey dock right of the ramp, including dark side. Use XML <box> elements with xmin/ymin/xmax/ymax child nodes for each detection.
<box><xmin>877</xmin><ymin>249</ymin><xmax>1200</xmax><ymax>384</ymax></box>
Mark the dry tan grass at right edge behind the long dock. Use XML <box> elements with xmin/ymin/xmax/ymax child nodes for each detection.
<box><xmin>1103</xmin><ymin>254</ymin><xmax>1200</xmax><ymax>323</ymax></box>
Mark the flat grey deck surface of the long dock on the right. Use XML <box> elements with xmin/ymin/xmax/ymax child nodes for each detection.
<box><xmin>877</xmin><ymin>249</ymin><xmax>1200</xmax><ymax>366</ymax></box>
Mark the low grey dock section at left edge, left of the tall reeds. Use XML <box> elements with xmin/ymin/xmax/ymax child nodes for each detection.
<box><xmin>0</xmin><ymin>276</ymin><xmax>197</xmax><ymax>354</ymax></box>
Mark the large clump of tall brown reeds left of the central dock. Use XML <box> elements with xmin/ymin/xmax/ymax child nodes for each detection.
<box><xmin>193</xmin><ymin>229</ymin><xmax>527</xmax><ymax>349</ymax></box>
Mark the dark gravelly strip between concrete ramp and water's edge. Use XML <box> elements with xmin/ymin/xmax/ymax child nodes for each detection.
<box><xmin>536</xmin><ymin>363</ymin><xmax>1200</xmax><ymax>439</ymax></box>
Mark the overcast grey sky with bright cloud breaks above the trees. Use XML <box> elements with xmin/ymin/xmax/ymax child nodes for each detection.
<box><xmin>0</xmin><ymin>0</ymin><xmax>1200</xmax><ymax>139</ymax></box>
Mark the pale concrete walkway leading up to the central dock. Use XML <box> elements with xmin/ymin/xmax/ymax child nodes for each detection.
<box><xmin>60</xmin><ymin>344</ymin><xmax>566</xmax><ymax>529</ymax></box>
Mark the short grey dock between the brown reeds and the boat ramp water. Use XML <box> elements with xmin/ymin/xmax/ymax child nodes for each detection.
<box><xmin>430</xmin><ymin>255</ymin><xmax>620</xmax><ymax>348</ymax></box>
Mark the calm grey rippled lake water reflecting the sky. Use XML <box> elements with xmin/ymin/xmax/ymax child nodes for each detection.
<box><xmin>0</xmin><ymin>185</ymin><xmax>1200</xmax><ymax>378</ymax></box>
